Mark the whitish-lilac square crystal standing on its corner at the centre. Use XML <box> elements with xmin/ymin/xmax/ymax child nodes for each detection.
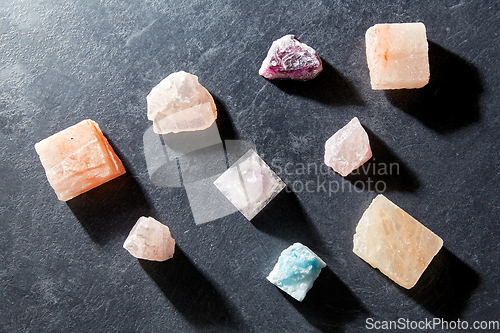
<box><xmin>214</xmin><ymin>149</ymin><xmax>285</xmax><ymax>221</ymax></box>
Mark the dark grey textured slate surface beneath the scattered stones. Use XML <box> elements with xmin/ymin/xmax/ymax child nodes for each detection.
<box><xmin>0</xmin><ymin>0</ymin><xmax>500</xmax><ymax>332</ymax></box>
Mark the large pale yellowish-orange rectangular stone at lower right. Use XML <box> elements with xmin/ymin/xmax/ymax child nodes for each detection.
<box><xmin>353</xmin><ymin>194</ymin><xmax>443</xmax><ymax>289</ymax></box>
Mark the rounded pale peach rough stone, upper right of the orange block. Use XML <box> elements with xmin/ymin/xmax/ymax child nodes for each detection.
<box><xmin>147</xmin><ymin>71</ymin><xmax>217</xmax><ymax>134</ymax></box>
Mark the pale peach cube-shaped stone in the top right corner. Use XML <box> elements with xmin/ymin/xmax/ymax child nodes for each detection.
<box><xmin>365</xmin><ymin>23</ymin><xmax>430</xmax><ymax>90</ymax></box>
